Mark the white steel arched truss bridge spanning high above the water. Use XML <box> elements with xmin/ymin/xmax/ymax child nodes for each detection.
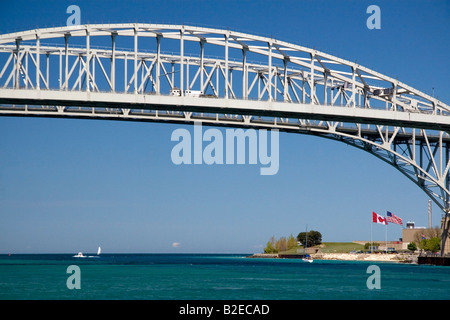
<box><xmin>0</xmin><ymin>23</ymin><xmax>450</xmax><ymax>252</ymax></box>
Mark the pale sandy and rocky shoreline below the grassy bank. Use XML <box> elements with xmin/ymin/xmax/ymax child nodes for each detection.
<box><xmin>248</xmin><ymin>252</ymin><xmax>419</xmax><ymax>264</ymax></box>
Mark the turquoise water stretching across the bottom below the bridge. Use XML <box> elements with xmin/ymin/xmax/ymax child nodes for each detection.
<box><xmin>0</xmin><ymin>254</ymin><xmax>450</xmax><ymax>300</ymax></box>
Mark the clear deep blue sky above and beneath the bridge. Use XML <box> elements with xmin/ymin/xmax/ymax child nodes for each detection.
<box><xmin>0</xmin><ymin>0</ymin><xmax>450</xmax><ymax>253</ymax></box>
